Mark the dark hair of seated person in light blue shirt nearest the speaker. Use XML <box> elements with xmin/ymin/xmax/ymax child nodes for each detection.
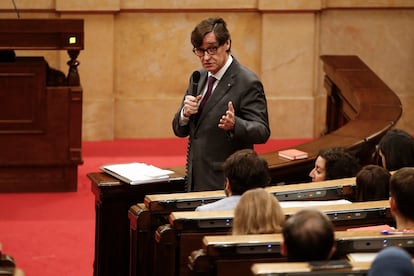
<box><xmin>223</xmin><ymin>149</ymin><xmax>270</xmax><ymax>195</ymax></box>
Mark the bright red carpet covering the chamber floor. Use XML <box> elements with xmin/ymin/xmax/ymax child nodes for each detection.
<box><xmin>0</xmin><ymin>139</ymin><xmax>309</xmax><ymax>276</ymax></box>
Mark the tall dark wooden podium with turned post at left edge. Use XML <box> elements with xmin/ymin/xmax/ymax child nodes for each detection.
<box><xmin>0</xmin><ymin>19</ymin><xmax>83</xmax><ymax>192</ymax></box>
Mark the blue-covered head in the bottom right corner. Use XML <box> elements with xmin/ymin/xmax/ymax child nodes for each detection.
<box><xmin>368</xmin><ymin>246</ymin><xmax>414</xmax><ymax>276</ymax></box>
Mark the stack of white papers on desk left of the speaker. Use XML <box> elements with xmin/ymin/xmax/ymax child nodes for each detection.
<box><xmin>100</xmin><ymin>162</ymin><xmax>174</xmax><ymax>185</ymax></box>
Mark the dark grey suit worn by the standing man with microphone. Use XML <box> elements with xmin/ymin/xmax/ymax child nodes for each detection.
<box><xmin>172</xmin><ymin>59</ymin><xmax>270</xmax><ymax>191</ymax></box>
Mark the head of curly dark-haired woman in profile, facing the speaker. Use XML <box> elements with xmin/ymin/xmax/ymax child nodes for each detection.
<box><xmin>309</xmin><ymin>147</ymin><xmax>360</xmax><ymax>182</ymax></box>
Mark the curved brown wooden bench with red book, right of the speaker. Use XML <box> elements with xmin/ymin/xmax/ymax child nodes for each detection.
<box><xmin>262</xmin><ymin>56</ymin><xmax>402</xmax><ymax>183</ymax></box>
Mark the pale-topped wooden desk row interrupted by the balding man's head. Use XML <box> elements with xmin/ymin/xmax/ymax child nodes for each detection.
<box><xmin>193</xmin><ymin>231</ymin><xmax>414</xmax><ymax>276</ymax></box>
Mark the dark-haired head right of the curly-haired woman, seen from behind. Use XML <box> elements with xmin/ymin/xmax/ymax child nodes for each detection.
<box><xmin>355</xmin><ymin>165</ymin><xmax>391</xmax><ymax>201</ymax></box>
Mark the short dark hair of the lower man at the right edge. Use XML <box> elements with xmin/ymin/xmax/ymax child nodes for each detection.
<box><xmin>390</xmin><ymin>167</ymin><xmax>414</xmax><ymax>221</ymax></box>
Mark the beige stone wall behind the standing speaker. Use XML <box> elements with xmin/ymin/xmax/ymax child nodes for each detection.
<box><xmin>0</xmin><ymin>0</ymin><xmax>414</xmax><ymax>140</ymax></box>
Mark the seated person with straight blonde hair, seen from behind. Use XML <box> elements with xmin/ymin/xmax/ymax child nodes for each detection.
<box><xmin>232</xmin><ymin>188</ymin><xmax>285</xmax><ymax>235</ymax></box>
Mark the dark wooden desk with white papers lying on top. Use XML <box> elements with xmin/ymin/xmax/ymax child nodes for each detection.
<box><xmin>88</xmin><ymin>173</ymin><xmax>185</xmax><ymax>276</ymax></box>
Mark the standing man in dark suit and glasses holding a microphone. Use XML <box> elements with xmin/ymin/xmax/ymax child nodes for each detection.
<box><xmin>172</xmin><ymin>18</ymin><xmax>270</xmax><ymax>191</ymax></box>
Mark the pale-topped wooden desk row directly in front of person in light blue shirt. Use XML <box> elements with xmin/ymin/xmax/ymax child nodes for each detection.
<box><xmin>128</xmin><ymin>177</ymin><xmax>355</xmax><ymax>276</ymax></box>
